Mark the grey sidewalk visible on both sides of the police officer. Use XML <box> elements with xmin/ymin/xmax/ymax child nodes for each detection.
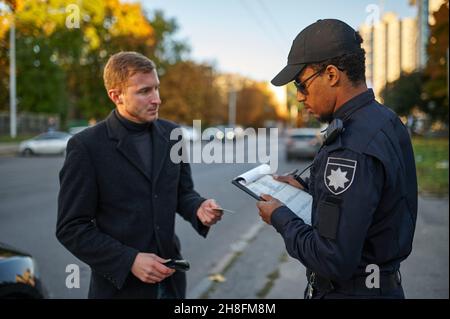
<box><xmin>188</xmin><ymin>197</ymin><xmax>449</xmax><ymax>299</ymax></box>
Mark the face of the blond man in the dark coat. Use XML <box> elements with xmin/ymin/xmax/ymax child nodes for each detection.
<box><xmin>117</xmin><ymin>70</ymin><xmax>161</xmax><ymax>123</ymax></box>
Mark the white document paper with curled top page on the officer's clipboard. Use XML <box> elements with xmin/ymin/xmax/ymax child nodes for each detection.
<box><xmin>238</xmin><ymin>164</ymin><xmax>312</xmax><ymax>225</ymax></box>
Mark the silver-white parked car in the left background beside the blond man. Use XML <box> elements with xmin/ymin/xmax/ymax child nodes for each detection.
<box><xmin>19</xmin><ymin>131</ymin><xmax>72</xmax><ymax>156</ymax></box>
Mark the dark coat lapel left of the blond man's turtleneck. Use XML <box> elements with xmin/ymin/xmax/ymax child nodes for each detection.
<box><xmin>106</xmin><ymin>111</ymin><xmax>151</xmax><ymax>182</ymax></box>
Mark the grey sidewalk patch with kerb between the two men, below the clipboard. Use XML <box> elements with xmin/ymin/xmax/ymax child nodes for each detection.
<box><xmin>188</xmin><ymin>222</ymin><xmax>306</xmax><ymax>299</ymax></box>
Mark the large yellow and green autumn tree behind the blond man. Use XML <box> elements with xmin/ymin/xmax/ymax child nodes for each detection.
<box><xmin>0</xmin><ymin>0</ymin><xmax>188</xmax><ymax>127</ymax></box>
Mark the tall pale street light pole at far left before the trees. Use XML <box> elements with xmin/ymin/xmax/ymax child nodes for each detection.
<box><xmin>9</xmin><ymin>13</ymin><xmax>17</xmax><ymax>138</ymax></box>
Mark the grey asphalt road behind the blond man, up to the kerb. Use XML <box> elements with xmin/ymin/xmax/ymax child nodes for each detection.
<box><xmin>0</xmin><ymin>136</ymin><xmax>308</xmax><ymax>298</ymax></box>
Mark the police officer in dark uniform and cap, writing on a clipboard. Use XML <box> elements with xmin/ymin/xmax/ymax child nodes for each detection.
<box><xmin>257</xmin><ymin>19</ymin><xmax>417</xmax><ymax>298</ymax></box>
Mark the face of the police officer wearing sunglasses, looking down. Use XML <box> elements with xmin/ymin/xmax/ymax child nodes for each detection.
<box><xmin>297</xmin><ymin>66</ymin><xmax>335</xmax><ymax>122</ymax></box>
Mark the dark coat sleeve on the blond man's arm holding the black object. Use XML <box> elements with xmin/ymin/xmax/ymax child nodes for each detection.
<box><xmin>56</xmin><ymin>137</ymin><xmax>138</xmax><ymax>289</ymax></box>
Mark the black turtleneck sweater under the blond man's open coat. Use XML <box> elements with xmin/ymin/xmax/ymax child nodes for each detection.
<box><xmin>114</xmin><ymin>109</ymin><xmax>152</xmax><ymax>175</ymax></box>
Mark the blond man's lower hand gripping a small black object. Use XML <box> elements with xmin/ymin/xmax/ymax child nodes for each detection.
<box><xmin>131</xmin><ymin>253</ymin><xmax>175</xmax><ymax>284</ymax></box>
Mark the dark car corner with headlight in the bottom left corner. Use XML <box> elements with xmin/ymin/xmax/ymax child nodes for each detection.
<box><xmin>0</xmin><ymin>243</ymin><xmax>47</xmax><ymax>299</ymax></box>
